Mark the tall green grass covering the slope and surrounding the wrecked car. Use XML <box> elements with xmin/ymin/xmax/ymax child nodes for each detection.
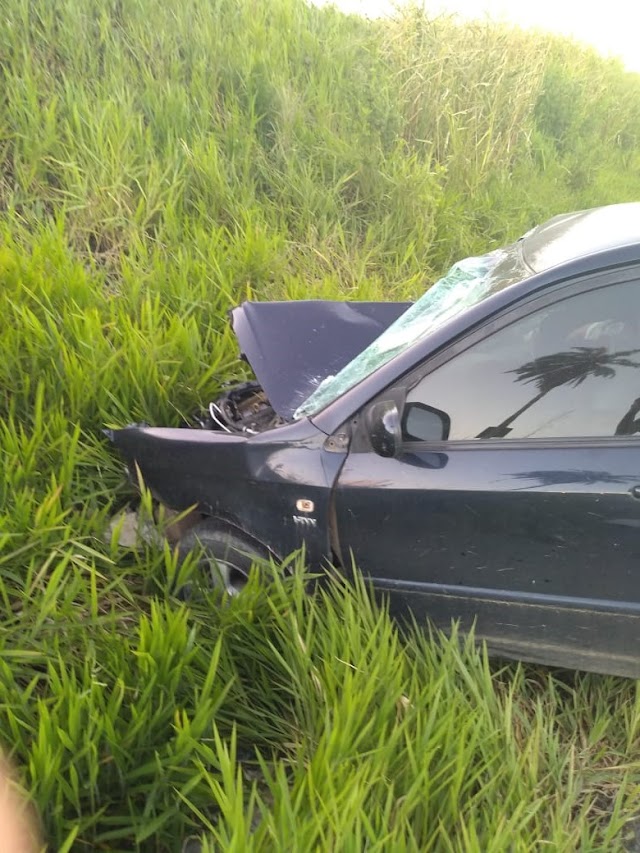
<box><xmin>0</xmin><ymin>0</ymin><xmax>640</xmax><ymax>853</ymax></box>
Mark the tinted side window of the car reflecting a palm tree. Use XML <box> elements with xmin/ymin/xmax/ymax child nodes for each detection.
<box><xmin>405</xmin><ymin>282</ymin><xmax>640</xmax><ymax>441</ymax></box>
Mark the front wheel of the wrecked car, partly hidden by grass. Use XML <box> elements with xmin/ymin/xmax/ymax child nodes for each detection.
<box><xmin>178</xmin><ymin>521</ymin><xmax>266</xmax><ymax>595</ymax></box>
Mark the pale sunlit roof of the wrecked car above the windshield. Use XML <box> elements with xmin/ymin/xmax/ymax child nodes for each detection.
<box><xmin>522</xmin><ymin>202</ymin><xmax>640</xmax><ymax>273</ymax></box>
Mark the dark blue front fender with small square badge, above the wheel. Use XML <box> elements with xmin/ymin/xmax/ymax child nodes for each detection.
<box><xmin>110</xmin><ymin>421</ymin><xmax>345</xmax><ymax>567</ymax></box>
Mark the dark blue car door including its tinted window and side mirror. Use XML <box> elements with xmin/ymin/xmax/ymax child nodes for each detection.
<box><xmin>335</xmin><ymin>273</ymin><xmax>640</xmax><ymax>676</ymax></box>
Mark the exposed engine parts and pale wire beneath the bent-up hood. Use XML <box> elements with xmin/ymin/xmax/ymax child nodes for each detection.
<box><xmin>195</xmin><ymin>382</ymin><xmax>286</xmax><ymax>435</ymax></box>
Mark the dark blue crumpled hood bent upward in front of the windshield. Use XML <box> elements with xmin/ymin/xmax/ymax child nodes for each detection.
<box><xmin>231</xmin><ymin>300</ymin><xmax>411</xmax><ymax>419</ymax></box>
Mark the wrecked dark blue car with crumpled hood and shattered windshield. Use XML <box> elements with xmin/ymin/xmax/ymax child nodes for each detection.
<box><xmin>109</xmin><ymin>203</ymin><xmax>640</xmax><ymax>678</ymax></box>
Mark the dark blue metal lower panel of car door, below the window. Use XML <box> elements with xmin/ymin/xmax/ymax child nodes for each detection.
<box><xmin>335</xmin><ymin>441</ymin><xmax>640</xmax><ymax>675</ymax></box>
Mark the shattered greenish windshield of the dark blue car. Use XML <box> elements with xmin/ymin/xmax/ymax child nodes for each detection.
<box><xmin>293</xmin><ymin>243</ymin><xmax>530</xmax><ymax>419</ymax></box>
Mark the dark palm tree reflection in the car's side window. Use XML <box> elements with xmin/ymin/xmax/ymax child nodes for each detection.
<box><xmin>478</xmin><ymin>347</ymin><xmax>640</xmax><ymax>438</ymax></box>
